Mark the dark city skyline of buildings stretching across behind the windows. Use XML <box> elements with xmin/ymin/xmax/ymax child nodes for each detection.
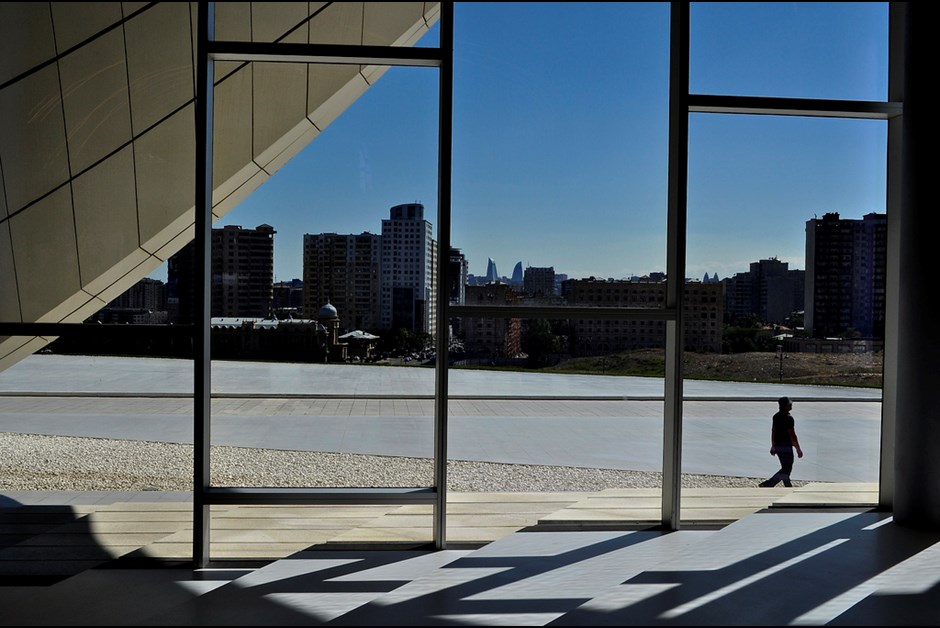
<box><xmin>97</xmin><ymin>209</ymin><xmax>888</xmax><ymax>365</ymax></box>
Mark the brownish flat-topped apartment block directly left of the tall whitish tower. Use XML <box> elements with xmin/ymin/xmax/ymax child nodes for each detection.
<box><xmin>303</xmin><ymin>232</ymin><xmax>382</xmax><ymax>332</ymax></box>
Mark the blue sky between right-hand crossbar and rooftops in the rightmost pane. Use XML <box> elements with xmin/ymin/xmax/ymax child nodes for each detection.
<box><xmin>686</xmin><ymin>114</ymin><xmax>887</xmax><ymax>279</ymax></box>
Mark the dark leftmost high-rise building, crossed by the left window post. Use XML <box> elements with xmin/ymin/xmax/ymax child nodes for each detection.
<box><xmin>167</xmin><ymin>224</ymin><xmax>277</xmax><ymax>323</ymax></box>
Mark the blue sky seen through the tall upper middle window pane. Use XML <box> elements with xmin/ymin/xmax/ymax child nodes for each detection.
<box><xmin>452</xmin><ymin>3</ymin><xmax>669</xmax><ymax>306</ymax></box>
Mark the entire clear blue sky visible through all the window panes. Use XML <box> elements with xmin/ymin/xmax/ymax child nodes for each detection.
<box><xmin>174</xmin><ymin>2</ymin><xmax>887</xmax><ymax>280</ymax></box>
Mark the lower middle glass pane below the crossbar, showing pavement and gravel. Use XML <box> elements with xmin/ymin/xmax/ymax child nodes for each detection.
<box><xmin>448</xmin><ymin>317</ymin><xmax>665</xmax><ymax>524</ymax></box>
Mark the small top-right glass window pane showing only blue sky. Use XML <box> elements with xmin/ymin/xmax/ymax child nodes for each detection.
<box><xmin>690</xmin><ymin>2</ymin><xmax>888</xmax><ymax>101</ymax></box>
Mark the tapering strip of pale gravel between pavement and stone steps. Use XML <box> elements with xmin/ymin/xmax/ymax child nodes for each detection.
<box><xmin>0</xmin><ymin>433</ymin><xmax>806</xmax><ymax>493</ymax></box>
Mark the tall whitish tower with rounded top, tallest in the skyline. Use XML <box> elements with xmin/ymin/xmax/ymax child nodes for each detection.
<box><xmin>380</xmin><ymin>203</ymin><xmax>437</xmax><ymax>334</ymax></box>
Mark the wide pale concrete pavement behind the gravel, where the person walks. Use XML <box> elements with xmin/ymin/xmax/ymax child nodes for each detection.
<box><xmin>0</xmin><ymin>355</ymin><xmax>881</xmax><ymax>482</ymax></box>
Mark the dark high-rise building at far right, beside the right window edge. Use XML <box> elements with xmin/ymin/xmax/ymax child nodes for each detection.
<box><xmin>804</xmin><ymin>212</ymin><xmax>888</xmax><ymax>339</ymax></box>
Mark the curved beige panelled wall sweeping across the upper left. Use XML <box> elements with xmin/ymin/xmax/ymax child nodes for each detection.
<box><xmin>0</xmin><ymin>2</ymin><xmax>440</xmax><ymax>370</ymax></box>
